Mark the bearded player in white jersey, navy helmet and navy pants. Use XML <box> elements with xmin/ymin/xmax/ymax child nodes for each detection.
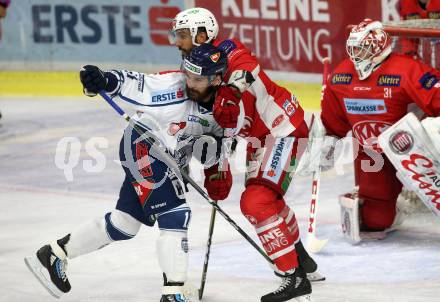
<box><xmin>25</xmin><ymin>44</ymin><xmax>232</xmax><ymax>302</ymax></box>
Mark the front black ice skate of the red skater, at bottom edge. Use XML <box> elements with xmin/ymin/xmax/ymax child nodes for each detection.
<box><xmin>261</xmin><ymin>267</ymin><xmax>313</xmax><ymax>302</ymax></box>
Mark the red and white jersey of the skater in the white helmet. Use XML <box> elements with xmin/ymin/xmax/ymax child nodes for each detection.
<box><xmin>214</xmin><ymin>39</ymin><xmax>307</xmax><ymax>138</ymax></box>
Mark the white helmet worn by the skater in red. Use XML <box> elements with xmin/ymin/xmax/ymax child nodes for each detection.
<box><xmin>173</xmin><ymin>7</ymin><xmax>218</xmax><ymax>46</ymax></box>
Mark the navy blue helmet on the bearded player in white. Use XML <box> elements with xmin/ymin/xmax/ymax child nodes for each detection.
<box><xmin>182</xmin><ymin>43</ymin><xmax>228</xmax><ymax>76</ymax></box>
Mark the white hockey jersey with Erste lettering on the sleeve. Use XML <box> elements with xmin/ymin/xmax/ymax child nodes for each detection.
<box><xmin>110</xmin><ymin>70</ymin><xmax>223</xmax><ymax>166</ymax></box>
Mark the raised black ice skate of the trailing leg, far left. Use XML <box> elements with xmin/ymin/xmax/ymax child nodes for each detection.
<box><xmin>24</xmin><ymin>242</ymin><xmax>71</xmax><ymax>301</ymax></box>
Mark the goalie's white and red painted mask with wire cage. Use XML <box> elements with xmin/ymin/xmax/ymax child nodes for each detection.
<box><xmin>346</xmin><ymin>19</ymin><xmax>391</xmax><ymax>80</ymax></box>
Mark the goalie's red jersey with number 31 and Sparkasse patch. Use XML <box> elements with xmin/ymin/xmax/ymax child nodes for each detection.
<box><xmin>321</xmin><ymin>54</ymin><xmax>440</xmax><ymax>151</ymax></box>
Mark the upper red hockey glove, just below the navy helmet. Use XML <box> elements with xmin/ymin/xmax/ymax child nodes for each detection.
<box><xmin>213</xmin><ymin>86</ymin><xmax>240</xmax><ymax>128</ymax></box>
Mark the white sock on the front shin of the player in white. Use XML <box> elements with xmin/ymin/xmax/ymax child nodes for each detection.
<box><xmin>157</xmin><ymin>231</ymin><xmax>188</xmax><ymax>282</ymax></box>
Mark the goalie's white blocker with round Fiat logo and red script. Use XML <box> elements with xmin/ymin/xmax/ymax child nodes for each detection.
<box><xmin>379</xmin><ymin>113</ymin><xmax>440</xmax><ymax>217</ymax></box>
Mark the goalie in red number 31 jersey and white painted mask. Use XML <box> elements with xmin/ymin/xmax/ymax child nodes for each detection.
<box><xmin>308</xmin><ymin>19</ymin><xmax>440</xmax><ymax>242</ymax></box>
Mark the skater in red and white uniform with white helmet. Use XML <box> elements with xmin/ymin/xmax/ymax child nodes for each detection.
<box><xmin>172</xmin><ymin>8</ymin><xmax>322</xmax><ymax>302</ymax></box>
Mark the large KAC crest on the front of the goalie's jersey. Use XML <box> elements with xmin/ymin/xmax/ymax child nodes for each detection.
<box><xmin>353</xmin><ymin>121</ymin><xmax>392</xmax><ymax>152</ymax></box>
